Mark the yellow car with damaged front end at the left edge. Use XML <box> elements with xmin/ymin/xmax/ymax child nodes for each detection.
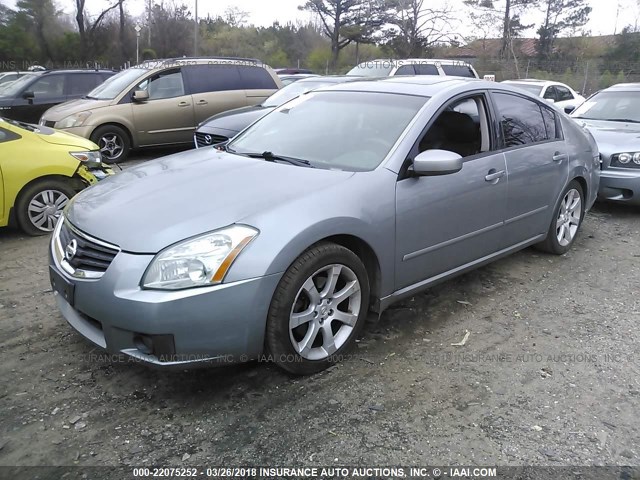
<box><xmin>0</xmin><ymin>117</ymin><xmax>113</xmax><ymax>235</ymax></box>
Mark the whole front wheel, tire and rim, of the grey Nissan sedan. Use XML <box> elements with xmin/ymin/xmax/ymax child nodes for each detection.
<box><xmin>266</xmin><ymin>243</ymin><xmax>369</xmax><ymax>375</ymax></box>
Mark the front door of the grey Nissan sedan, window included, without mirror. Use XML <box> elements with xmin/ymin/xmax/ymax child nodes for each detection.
<box><xmin>396</xmin><ymin>93</ymin><xmax>507</xmax><ymax>290</ymax></box>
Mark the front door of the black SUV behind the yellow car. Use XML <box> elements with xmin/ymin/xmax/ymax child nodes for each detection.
<box><xmin>11</xmin><ymin>73</ymin><xmax>67</xmax><ymax>123</ymax></box>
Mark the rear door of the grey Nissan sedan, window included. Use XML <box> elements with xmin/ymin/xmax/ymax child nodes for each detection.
<box><xmin>492</xmin><ymin>92</ymin><xmax>569</xmax><ymax>244</ymax></box>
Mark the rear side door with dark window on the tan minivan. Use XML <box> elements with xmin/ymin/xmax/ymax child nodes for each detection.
<box><xmin>183</xmin><ymin>63</ymin><xmax>247</xmax><ymax>124</ymax></box>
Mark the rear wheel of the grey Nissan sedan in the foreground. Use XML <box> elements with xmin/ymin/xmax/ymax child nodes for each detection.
<box><xmin>537</xmin><ymin>180</ymin><xmax>585</xmax><ymax>255</ymax></box>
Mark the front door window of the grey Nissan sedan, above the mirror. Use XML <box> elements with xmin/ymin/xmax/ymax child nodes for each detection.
<box><xmin>418</xmin><ymin>95</ymin><xmax>491</xmax><ymax>158</ymax></box>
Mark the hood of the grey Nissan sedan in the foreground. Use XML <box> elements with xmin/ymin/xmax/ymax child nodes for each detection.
<box><xmin>65</xmin><ymin>150</ymin><xmax>353</xmax><ymax>254</ymax></box>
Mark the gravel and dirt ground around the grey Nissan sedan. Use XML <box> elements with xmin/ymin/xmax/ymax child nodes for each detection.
<box><xmin>0</xmin><ymin>151</ymin><xmax>640</xmax><ymax>472</ymax></box>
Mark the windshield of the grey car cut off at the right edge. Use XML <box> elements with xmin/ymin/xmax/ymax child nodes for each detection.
<box><xmin>571</xmin><ymin>91</ymin><xmax>640</xmax><ymax>122</ymax></box>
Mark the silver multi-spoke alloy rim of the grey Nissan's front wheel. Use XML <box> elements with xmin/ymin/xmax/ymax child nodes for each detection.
<box><xmin>289</xmin><ymin>264</ymin><xmax>362</xmax><ymax>360</ymax></box>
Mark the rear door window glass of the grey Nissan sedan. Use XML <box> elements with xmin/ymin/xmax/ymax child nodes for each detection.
<box><xmin>493</xmin><ymin>93</ymin><xmax>548</xmax><ymax>148</ymax></box>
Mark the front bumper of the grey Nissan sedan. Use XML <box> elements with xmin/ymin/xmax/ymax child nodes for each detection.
<box><xmin>49</xmin><ymin>221</ymin><xmax>281</xmax><ymax>367</ymax></box>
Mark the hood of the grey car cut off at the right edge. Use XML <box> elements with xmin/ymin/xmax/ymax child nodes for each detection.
<box><xmin>574</xmin><ymin>118</ymin><xmax>640</xmax><ymax>157</ymax></box>
